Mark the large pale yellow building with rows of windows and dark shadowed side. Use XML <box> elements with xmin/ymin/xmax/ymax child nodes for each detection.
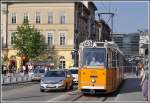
<box><xmin>2</xmin><ymin>2</ymin><xmax>96</xmax><ymax>68</ymax></box>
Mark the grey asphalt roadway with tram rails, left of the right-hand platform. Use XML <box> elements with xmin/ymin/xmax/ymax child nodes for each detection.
<box><xmin>2</xmin><ymin>84</ymin><xmax>116</xmax><ymax>101</ymax></box>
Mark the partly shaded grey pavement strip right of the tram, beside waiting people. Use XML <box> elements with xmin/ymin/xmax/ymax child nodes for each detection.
<box><xmin>115</xmin><ymin>74</ymin><xmax>144</xmax><ymax>102</ymax></box>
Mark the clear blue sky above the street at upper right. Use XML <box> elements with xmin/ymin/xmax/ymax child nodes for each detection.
<box><xmin>94</xmin><ymin>1</ymin><xmax>149</xmax><ymax>33</ymax></box>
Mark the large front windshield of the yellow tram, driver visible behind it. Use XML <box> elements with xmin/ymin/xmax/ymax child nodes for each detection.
<box><xmin>83</xmin><ymin>48</ymin><xmax>106</xmax><ymax>66</ymax></box>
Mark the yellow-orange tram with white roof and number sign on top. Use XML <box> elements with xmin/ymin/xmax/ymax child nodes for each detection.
<box><xmin>78</xmin><ymin>40</ymin><xmax>124</xmax><ymax>94</ymax></box>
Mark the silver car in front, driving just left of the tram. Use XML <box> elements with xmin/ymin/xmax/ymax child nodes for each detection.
<box><xmin>40</xmin><ymin>69</ymin><xmax>73</xmax><ymax>92</ymax></box>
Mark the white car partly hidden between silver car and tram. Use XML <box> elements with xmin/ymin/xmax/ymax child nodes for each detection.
<box><xmin>69</xmin><ymin>67</ymin><xmax>78</xmax><ymax>84</ymax></box>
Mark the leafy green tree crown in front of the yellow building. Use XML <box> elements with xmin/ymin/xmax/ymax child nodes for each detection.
<box><xmin>13</xmin><ymin>21</ymin><xmax>46</xmax><ymax>60</ymax></box>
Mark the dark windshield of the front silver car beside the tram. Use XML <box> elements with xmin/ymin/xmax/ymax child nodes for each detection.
<box><xmin>45</xmin><ymin>71</ymin><xmax>65</xmax><ymax>77</ymax></box>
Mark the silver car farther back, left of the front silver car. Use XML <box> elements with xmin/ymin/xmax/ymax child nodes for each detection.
<box><xmin>29</xmin><ymin>68</ymin><xmax>45</xmax><ymax>81</ymax></box>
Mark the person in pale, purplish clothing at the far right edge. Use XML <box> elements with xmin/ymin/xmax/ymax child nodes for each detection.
<box><xmin>139</xmin><ymin>64</ymin><xmax>148</xmax><ymax>101</ymax></box>
